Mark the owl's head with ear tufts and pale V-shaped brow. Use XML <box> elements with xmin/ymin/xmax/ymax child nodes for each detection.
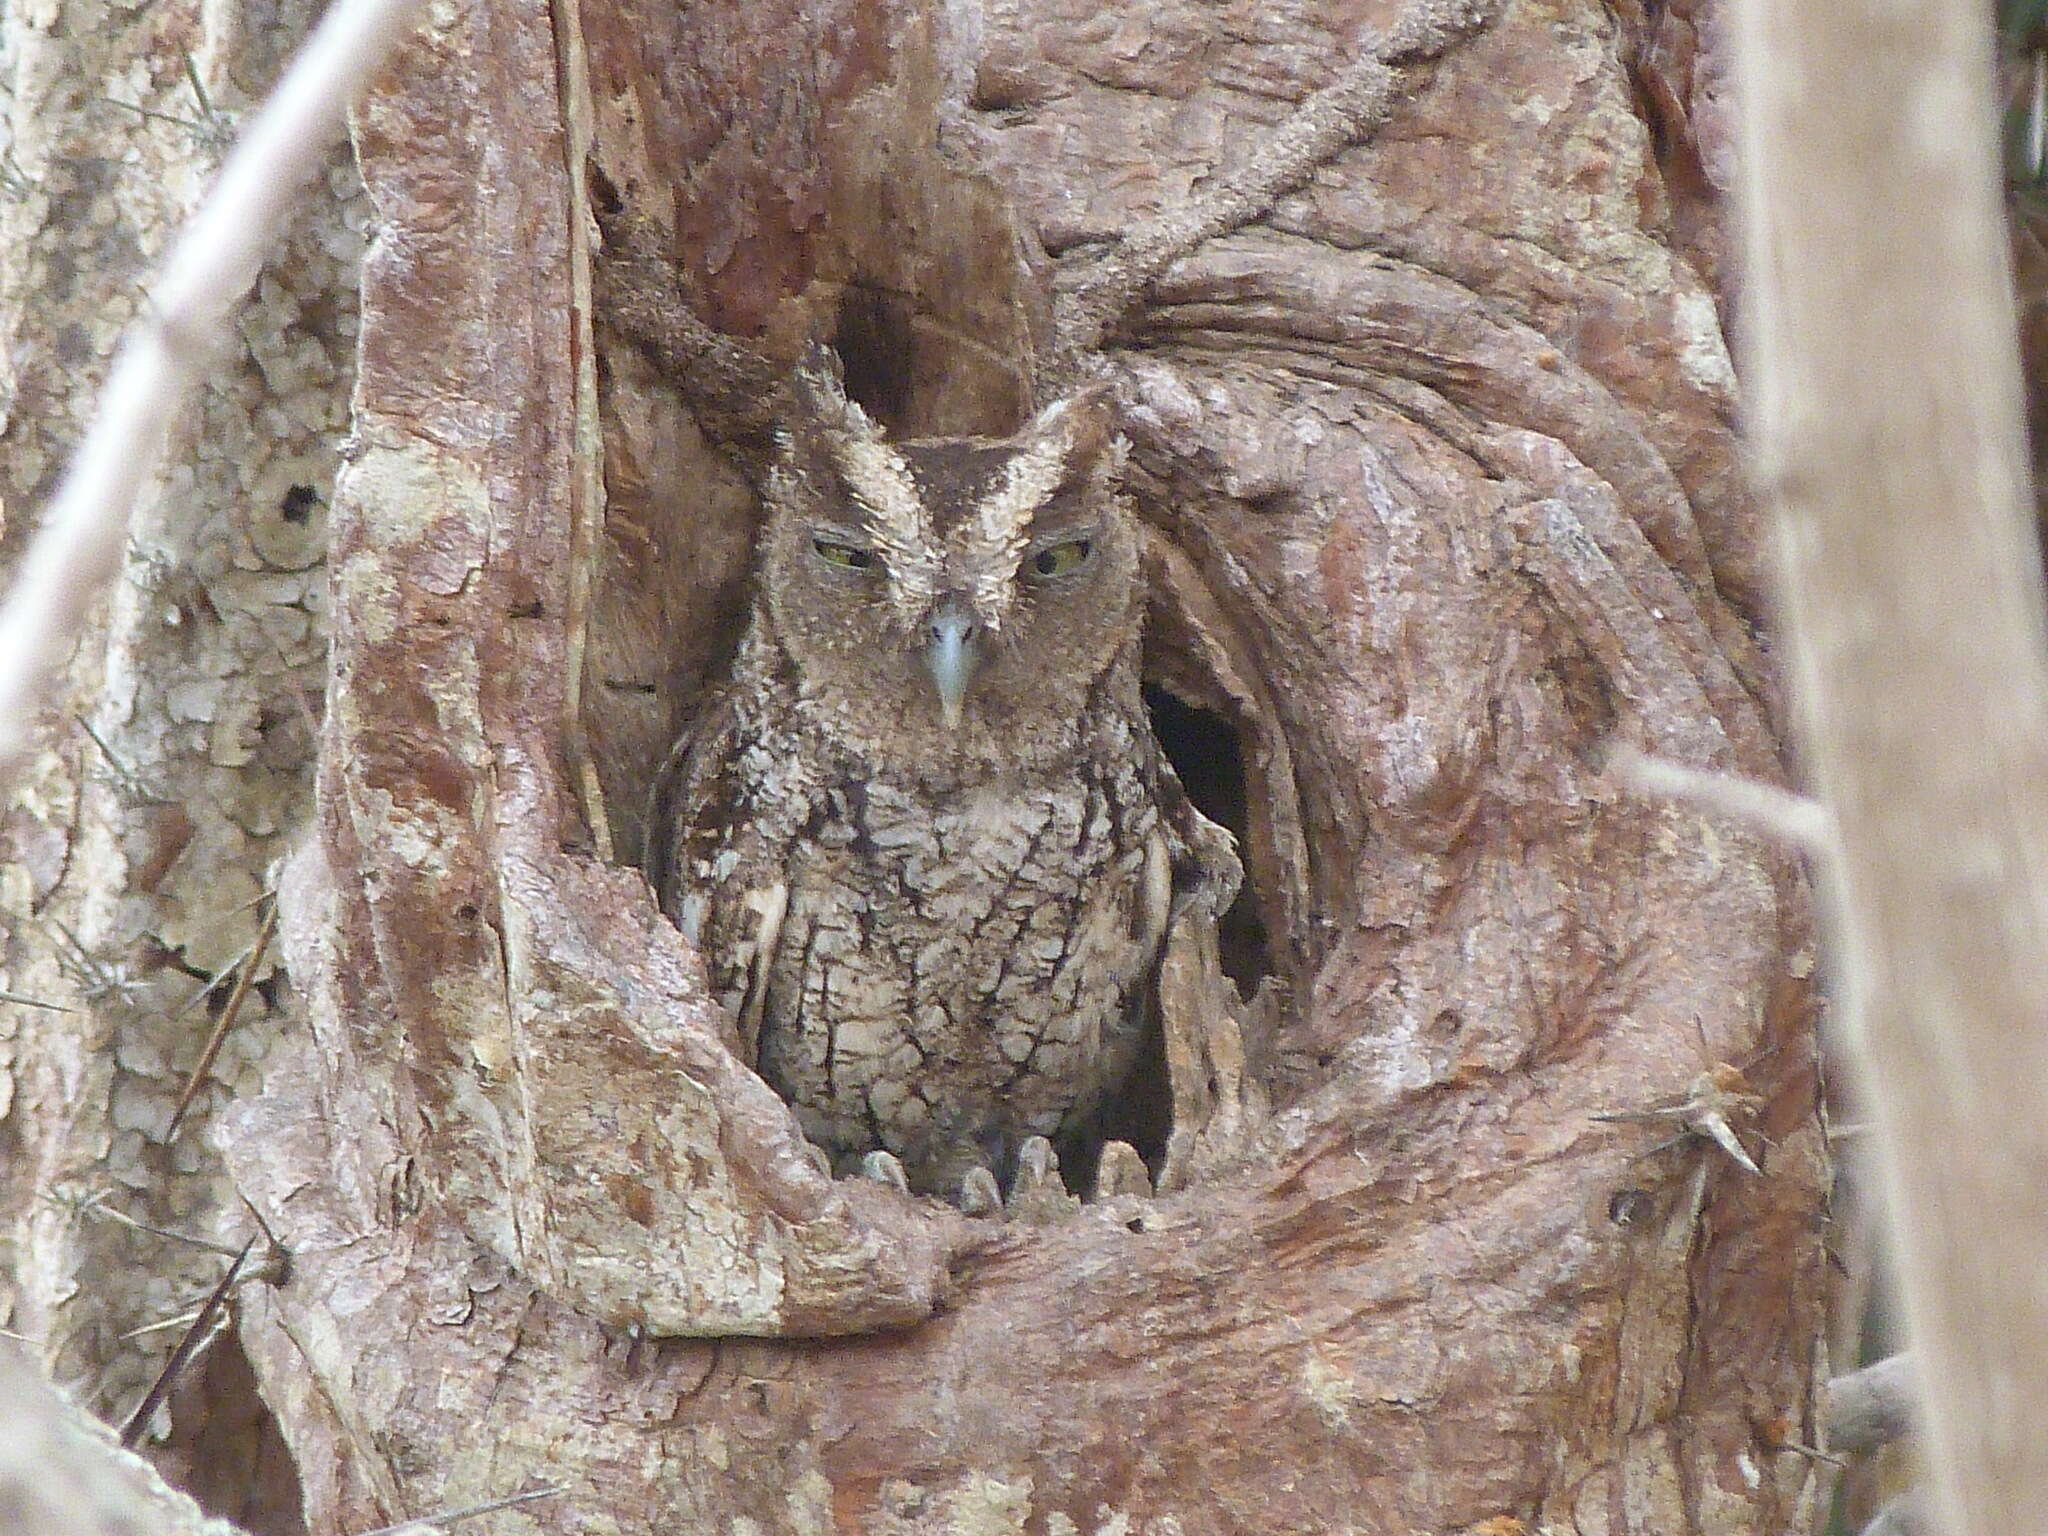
<box><xmin>760</xmin><ymin>360</ymin><xmax>1141</xmax><ymax>764</ymax></box>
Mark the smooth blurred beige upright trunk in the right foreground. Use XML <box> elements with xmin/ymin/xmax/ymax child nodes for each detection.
<box><xmin>1741</xmin><ymin>4</ymin><xmax>2048</xmax><ymax>1536</ymax></box>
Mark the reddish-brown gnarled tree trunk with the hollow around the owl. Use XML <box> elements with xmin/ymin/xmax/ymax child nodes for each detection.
<box><xmin>10</xmin><ymin>0</ymin><xmax>1825</xmax><ymax>1534</ymax></box>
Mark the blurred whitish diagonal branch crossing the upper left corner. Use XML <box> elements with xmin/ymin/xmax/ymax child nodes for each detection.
<box><xmin>0</xmin><ymin>0</ymin><xmax>418</xmax><ymax>786</ymax></box>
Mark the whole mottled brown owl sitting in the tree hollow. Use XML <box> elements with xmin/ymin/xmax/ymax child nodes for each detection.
<box><xmin>649</xmin><ymin>352</ymin><xmax>1239</xmax><ymax>1200</ymax></box>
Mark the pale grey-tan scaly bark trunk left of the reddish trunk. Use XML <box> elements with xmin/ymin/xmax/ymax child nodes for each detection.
<box><xmin>0</xmin><ymin>0</ymin><xmax>367</xmax><ymax>1530</ymax></box>
